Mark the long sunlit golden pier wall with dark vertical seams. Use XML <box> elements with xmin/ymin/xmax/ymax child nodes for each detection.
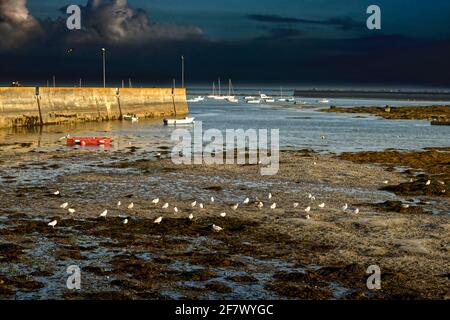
<box><xmin>0</xmin><ymin>87</ymin><xmax>189</xmax><ymax>128</ymax></box>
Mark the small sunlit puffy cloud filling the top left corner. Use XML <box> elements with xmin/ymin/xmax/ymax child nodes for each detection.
<box><xmin>0</xmin><ymin>0</ymin><xmax>43</xmax><ymax>50</ymax></box>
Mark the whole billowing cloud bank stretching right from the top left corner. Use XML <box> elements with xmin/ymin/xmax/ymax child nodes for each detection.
<box><xmin>0</xmin><ymin>0</ymin><xmax>203</xmax><ymax>49</ymax></box>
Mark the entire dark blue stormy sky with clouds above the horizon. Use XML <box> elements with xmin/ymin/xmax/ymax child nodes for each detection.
<box><xmin>0</xmin><ymin>0</ymin><xmax>450</xmax><ymax>87</ymax></box>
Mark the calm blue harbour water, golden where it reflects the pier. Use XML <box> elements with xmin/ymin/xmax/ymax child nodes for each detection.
<box><xmin>0</xmin><ymin>99</ymin><xmax>450</xmax><ymax>153</ymax></box>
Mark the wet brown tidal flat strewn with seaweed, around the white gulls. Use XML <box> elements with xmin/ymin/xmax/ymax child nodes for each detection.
<box><xmin>0</xmin><ymin>146</ymin><xmax>450</xmax><ymax>299</ymax></box>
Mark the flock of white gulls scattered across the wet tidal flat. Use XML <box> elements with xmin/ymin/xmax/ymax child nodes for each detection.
<box><xmin>48</xmin><ymin>191</ymin><xmax>359</xmax><ymax>232</ymax></box>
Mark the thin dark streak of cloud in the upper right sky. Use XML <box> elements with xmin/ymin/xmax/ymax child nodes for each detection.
<box><xmin>247</xmin><ymin>14</ymin><xmax>365</xmax><ymax>30</ymax></box>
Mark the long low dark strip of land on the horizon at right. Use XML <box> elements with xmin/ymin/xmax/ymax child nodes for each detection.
<box><xmin>294</xmin><ymin>90</ymin><xmax>450</xmax><ymax>101</ymax></box>
